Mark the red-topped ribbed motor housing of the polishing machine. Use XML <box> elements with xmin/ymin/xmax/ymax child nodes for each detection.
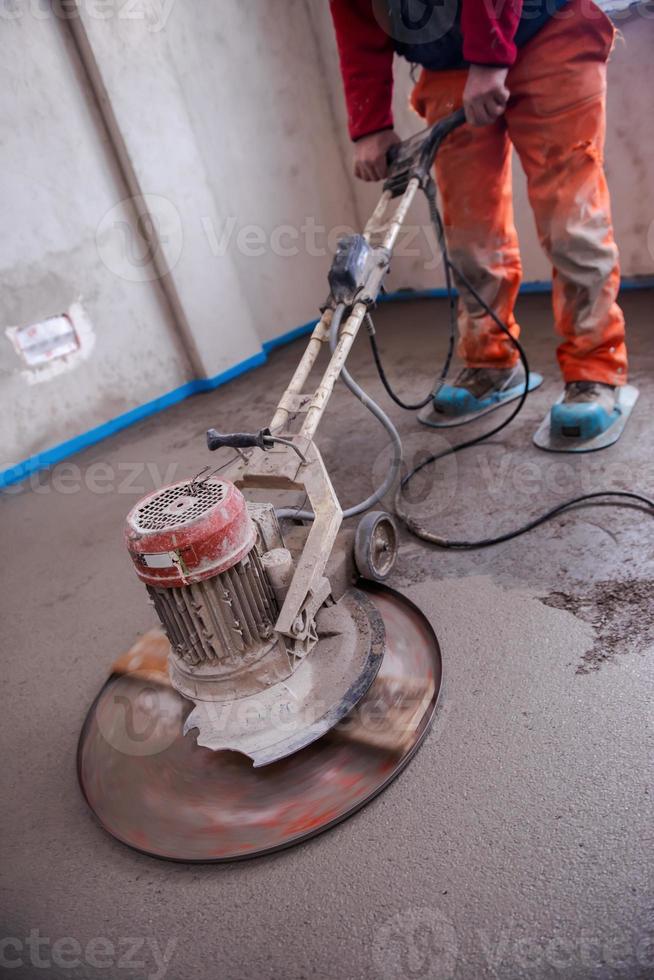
<box><xmin>126</xmin><ymin>479</ymin><xmax>292</xmax><ymax>701</ymax></box>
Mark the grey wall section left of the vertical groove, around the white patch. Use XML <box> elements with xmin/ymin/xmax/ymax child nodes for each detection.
<box><xmin>0</xmin><ymin>16</ymin><xmax>188</xmax><ymax>469</ymax></box>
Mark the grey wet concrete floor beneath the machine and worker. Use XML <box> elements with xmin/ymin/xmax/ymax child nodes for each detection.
<box><xmin>0</xmin><ymin>293</ymin><xmax>654</xmax><ymax>980</ymax></box>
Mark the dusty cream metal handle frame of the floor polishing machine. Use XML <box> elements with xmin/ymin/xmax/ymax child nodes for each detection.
<box><xmin>207</xmin><ymin>110</ymin><xmax>465</xmax><ymax>644</ymax></box>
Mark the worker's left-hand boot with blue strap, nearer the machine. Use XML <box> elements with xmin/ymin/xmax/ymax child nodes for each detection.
<box><xmin>432</xmin><ymin>364</ymin><xmax>525</xmax><ymax>416</ymax></box>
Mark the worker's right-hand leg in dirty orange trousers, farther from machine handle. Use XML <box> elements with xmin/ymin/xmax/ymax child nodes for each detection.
<box><xmin>506</xmin><ymin>0</ymin><xmax>627</xmax><ymax>385</ymax></box>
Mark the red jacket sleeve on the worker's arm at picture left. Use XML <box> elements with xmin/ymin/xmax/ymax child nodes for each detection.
<box><xmin>329</xmin><ymin>0</ymin><xmax>393</xmax><ymax>140</ymax></box>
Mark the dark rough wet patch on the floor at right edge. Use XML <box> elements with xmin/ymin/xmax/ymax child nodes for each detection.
<box><xmin>540</xmin><ymin>579</ymin><xmax>654</xmax><ymax>674</ymax></box>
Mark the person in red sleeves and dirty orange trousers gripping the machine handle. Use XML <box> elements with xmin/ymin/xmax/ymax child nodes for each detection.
<box><xmin>330</xmin><ymin>0</ymin><xmax>627</xmax><ymax>438</ymax></box>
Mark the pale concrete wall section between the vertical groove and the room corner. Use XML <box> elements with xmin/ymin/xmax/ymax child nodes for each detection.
<box><xmin>74</xmin><ymin>0</ymin><xmax>362</xmax><ymax>364</ymax></box>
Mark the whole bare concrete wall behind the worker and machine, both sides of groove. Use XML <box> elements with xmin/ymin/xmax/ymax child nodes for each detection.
<box><xmin>0</xmin><ymin>0</ymin><xmax>654</xmax><ymax>473</ymax></box>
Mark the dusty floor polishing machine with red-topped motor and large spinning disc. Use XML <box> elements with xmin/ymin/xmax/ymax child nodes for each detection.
<box><xmin>78</xmin><ymin>112</ymin><xmax>464</xmax><ymax>861</ymax></box>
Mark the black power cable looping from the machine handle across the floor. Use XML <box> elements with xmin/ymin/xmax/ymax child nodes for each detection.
<box><xmin>368</xmin><ymin>179</ymin><xmax>654</xmax><ymax>551</ymax></box>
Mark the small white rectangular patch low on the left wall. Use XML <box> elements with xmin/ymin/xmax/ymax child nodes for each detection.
<box><xmin>5</xmin><ymin>302</ymin><xmax>95</xmax><ymax>384</ymax></box>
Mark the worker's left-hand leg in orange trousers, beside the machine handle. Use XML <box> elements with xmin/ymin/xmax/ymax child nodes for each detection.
<box><xmin>411</xmin><ymin>71</ymin><xmax>521</xmax><ymax>368</ymax></box>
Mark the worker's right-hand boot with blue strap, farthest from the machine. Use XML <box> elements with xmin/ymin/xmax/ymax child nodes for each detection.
<box><xmin>550</xmin><ymin>381</ymin><xmax>620</xmax><ymax>440</ymax></box>
